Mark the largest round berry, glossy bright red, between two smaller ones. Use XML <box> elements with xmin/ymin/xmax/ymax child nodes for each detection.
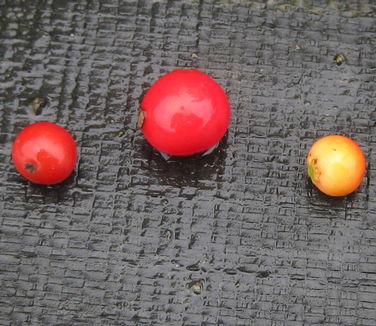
<box><xmin>139</xmin><ymin>69</ymin><xmax>231</xmax><ymax>156</ymax></box>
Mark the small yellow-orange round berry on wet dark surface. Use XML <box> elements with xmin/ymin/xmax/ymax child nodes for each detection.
<box><xmin>307</xmin><ymin>135</ymin><xmax>366</xmax><ymax>196</ymax></box>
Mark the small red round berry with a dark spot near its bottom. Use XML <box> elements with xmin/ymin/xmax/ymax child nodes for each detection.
<box><xmin>12</xmin><ymin>121</ymin><xmax>77</xmax><ymax>185</ymax></box>
